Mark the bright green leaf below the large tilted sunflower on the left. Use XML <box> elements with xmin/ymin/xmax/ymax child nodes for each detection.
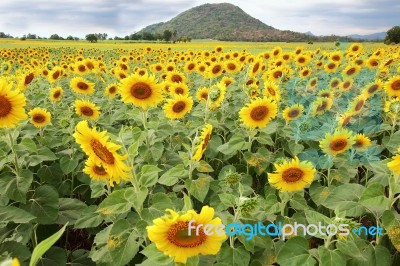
<box><xmin>96</xmin><ymin>187</ymin><xmax>136</xmax><ymax>215</ymax></box>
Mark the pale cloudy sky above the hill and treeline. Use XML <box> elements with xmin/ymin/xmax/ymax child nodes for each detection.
<box><xmin>0</xmin><ymin>0</ymin><xmax>400</xmax><ymax>37</ymax></box>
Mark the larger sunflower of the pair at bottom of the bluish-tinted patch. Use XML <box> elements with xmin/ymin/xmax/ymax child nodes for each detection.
<box><xmin>319</xmin><ymin>128</ymin><xmax>356</xmax><ymax>156</ymax></box>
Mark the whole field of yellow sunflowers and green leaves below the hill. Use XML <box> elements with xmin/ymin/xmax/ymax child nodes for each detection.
<box><xmin>0</xmin><ymin>40</ymin><xmax>400</xmax><ymax>266</ymax></box>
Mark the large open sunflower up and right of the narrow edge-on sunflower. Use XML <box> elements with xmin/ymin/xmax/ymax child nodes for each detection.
<box><xmin>239</xmin><ymin>97</ymin><xmax>278</xmax><ymax>128</ymax></box>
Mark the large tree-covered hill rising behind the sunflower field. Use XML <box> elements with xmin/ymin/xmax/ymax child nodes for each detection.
<box><xmin>137</xmin><ymin>3</ymin><xmax>315</xmax><ymax>41</ymax></box>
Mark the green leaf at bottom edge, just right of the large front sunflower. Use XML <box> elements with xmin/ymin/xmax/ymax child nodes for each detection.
<box><xmin>217</xmin><ymin>243</ymin><xmax>250</xmax><ymax>266</ymax></box>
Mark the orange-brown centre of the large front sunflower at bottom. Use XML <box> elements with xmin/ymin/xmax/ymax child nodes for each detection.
<box><xmin>167</xmin><ymin>221</ymin><xmax>207</xmax><ymax>248</ymax></box>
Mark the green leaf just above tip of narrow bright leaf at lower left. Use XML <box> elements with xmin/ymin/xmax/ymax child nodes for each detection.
<box><xmin>57</xmin><ymin>198</ymin><xmax>87</xmax><ymax>225</ymax></box>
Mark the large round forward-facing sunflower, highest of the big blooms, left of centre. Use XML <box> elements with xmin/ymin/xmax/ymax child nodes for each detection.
<box><xmin>119</xmin><ymin>74</ymin><xmax>163</xmax><ymax>109</ymax></box>
